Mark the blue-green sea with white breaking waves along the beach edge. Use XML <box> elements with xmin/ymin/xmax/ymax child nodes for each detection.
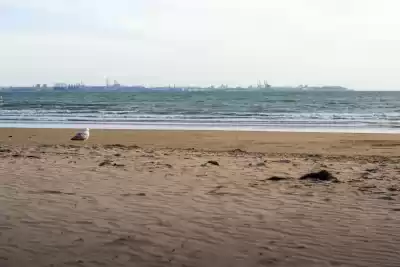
<box><xmin>0</xmin><ymin>90</ymin><xmax>400</xmax><ymax>133</ymax></box>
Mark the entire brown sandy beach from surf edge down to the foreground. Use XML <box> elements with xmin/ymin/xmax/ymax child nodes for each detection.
<box><xmin>0</xmin><ymin>129</ymin><xmax>400</xmax><ymax>267</ymax></box>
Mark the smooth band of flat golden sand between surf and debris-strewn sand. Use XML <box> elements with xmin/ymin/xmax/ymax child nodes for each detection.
<box><xmin>0</xmin><ymin>128</ymin><xmax>400</xmax><ymax>156</ymax></box>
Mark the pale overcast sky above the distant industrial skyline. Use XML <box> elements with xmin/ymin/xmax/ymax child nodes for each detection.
<box><xmin>0</xmin><ymin>0</ymin><xmax>400</xmax><ymax>89</ymax></box>
